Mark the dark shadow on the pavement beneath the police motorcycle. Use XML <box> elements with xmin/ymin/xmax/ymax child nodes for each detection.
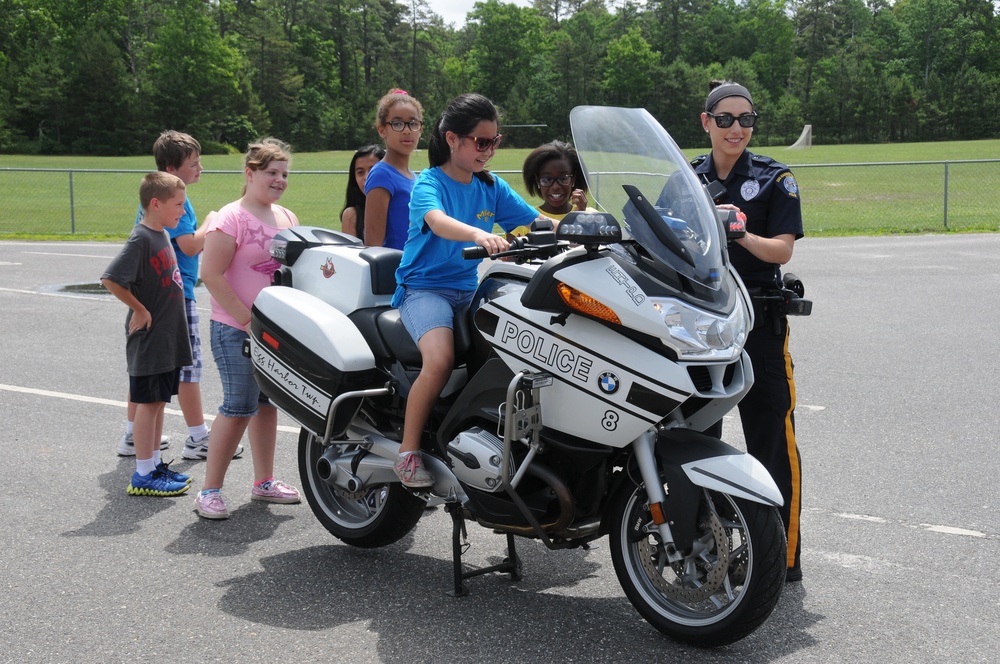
<box><xmin>209</xmin><ymin>538</ymin><xmax>822</xmax><ymax>662</ymax></box>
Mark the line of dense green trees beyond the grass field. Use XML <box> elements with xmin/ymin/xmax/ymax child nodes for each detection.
<box><xmin>0</xmin><ymin>0</ymin><xmax>1000</xmax><ymax>155</ymax></box>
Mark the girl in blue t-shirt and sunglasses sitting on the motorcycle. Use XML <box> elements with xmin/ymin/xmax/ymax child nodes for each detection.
<box><xmin>390</xmin><ymin>94</ymin><xmax>552</xmax><ymax>488</ymax></box>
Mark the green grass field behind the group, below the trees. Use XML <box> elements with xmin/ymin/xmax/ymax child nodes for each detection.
<box><xmin>0</xmin><ymin>140</ymin><xmax>1000</xmax><ymax>240</ymax></box>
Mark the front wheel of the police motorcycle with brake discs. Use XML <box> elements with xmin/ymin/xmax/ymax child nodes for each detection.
<box><xmin>610</xmin><ymin>482</ymin><xmax>786</xmax><ymax>648</ymax></box>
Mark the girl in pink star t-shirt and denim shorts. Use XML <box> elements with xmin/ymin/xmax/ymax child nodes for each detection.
<box><xmin>195</xmin><ymin>138</ymin><xmax>300</xmax><ymax>519</ymax></box>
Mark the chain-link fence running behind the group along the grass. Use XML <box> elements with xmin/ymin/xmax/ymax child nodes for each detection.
<box><xmin>0</xmin><ymin>159</ymin><xmax>1000</xmax><ymax>238</ymax></box>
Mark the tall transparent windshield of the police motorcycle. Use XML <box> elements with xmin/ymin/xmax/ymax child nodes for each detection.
<box><xmin>570</xmin><ymin>106</ymin><xmax>725</xmax><ymax>290</ymax></box>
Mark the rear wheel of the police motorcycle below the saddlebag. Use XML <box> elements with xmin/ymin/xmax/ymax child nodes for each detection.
<box><xmin>299</xmin><ymin>429</ymin><xmax>425</xmax><ymax>549</ymax></box>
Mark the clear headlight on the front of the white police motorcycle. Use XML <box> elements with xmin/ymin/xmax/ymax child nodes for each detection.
<box><xmin>653</xmin><ymin>299</ymin><xmax>749</xmax><ymax>360</ymax></box>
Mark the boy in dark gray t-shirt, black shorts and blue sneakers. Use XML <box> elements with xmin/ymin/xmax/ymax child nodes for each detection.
<box><xmin>101</xmin><ymin>171</ymin><xmax>191</xmax><ymax>496</ymax></box>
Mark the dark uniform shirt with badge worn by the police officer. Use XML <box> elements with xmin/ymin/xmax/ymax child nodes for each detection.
<box><xmin>691</xmin><ymin>150</ymin><xmax>802</xmax><ymax>288</ymax></box>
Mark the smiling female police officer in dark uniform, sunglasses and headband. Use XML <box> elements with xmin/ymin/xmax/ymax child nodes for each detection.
<box><xmin>691</xmin><ymin>81</ymin><xmax>803</xmax><ymax>581</ymax></box>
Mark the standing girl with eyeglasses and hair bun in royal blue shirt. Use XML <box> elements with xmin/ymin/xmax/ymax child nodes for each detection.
<box><xmin>364</xmin><ymin>89</ymin><xmax>424</xmax><ymax>249</ymax></box>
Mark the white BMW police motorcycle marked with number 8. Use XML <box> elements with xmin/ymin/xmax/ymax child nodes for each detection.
<box><xmin>247</xmin><ymin>107</ymin><xmax>785</xmax><ymax>647</ymax></box>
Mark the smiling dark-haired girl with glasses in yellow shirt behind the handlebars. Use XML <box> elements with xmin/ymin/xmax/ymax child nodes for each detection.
<box><xmin>514</xmin><ymin>141</ymin><xmax>587</xmax><ymax>223</ymax></box>
